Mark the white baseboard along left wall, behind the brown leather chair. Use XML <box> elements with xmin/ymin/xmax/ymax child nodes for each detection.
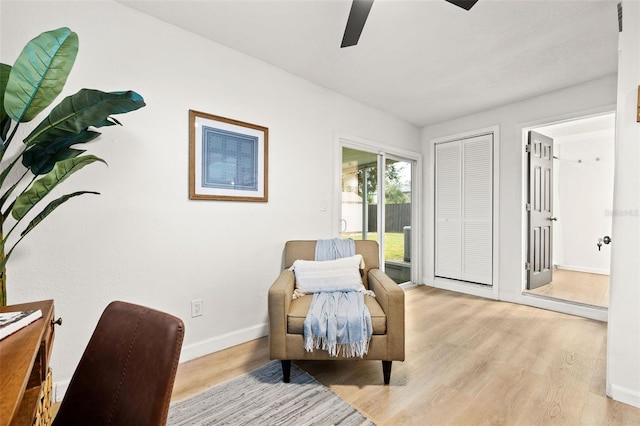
<box><xmin>53</xmin><ymin>323</ymin><xmax>268</xmax><ymax>402</ymax></box>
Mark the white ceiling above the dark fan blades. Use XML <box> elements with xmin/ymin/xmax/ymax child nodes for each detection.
<box><xmin>118</xmin><ymin>0</ymin><xmax>618</xmax><ymax>126</ymax></box>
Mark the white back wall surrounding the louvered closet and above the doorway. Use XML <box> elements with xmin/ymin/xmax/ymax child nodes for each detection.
<box><xmin>422</xmin><ymin>75</ymin><xmax>616</xmax><ymax>302</ymax></box>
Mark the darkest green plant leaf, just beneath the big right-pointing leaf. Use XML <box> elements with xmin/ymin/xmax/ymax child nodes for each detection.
<box><xmin>22</xmin><ymin>130</ymin><xmax>100</xmax><ymax>176</ymax></box>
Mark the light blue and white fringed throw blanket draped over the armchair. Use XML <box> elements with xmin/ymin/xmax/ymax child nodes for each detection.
<box><xmin>304</xmin><ymin>238</ymin><xmax>373</xmax><ymax>358</ymax></box>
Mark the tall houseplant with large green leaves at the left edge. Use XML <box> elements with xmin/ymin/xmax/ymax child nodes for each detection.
<box><xmin>0</xmin><ymin>28</ymin><xmax>145</xmax><ymax>306</ymax></box>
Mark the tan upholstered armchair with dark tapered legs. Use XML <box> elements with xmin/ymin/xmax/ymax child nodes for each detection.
<box><xmin>269</xmin><ymin>240</ymin><xmax>404</xmax><ymax>384</ymax></box>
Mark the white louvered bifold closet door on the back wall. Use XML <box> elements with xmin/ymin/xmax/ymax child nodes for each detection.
<box><xmin>435</xmin><ymin>135</ymin><xmax>493</xmax><ymax>285</ymax></box>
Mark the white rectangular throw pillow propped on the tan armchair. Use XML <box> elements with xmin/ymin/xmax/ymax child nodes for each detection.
<box><xmin>290</xmin><ymin>254</ymin><xmax>365</xmax><ymax>294</ymax></box>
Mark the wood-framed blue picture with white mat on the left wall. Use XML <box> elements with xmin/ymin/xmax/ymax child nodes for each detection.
<box><xmin>189</xmin><ymin>110</ymin><xmax>269</xmax><ymax>202</ymax></box>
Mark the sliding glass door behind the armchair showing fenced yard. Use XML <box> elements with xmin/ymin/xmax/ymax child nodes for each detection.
<box><xmin>340</xmin><ymin>146</ymin><xmax>416</xmax><ymax>284</ymax></box>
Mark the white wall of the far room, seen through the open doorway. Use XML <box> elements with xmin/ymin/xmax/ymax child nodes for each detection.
<box><xmin>553</xmin><ymin>132</ymin><xmax>615</xmax><ymax>274</ymax></box>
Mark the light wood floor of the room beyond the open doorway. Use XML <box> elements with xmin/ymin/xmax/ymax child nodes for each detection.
<box><xmin>528</xmin><ymin>269</ymin><xmax>609</xmax><ymax>308</ymax></box>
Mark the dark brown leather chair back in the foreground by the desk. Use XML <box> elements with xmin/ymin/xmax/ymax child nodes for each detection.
<box><xmin>53</xmin><ymin>302</ymin><xmax>184</xmax><ymax>426</ymax></box>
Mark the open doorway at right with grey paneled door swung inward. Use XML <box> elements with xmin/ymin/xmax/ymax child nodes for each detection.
<box><xmin>525</xmin><ymin>113</ymin><xmax>615</xmax><ymax>308</ymax></box>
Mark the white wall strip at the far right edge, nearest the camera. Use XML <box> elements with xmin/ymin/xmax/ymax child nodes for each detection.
<box><xmin>607</xmin><ymin>1</ymin><xmax>640</xmax><ymax>407</ymax></box>
